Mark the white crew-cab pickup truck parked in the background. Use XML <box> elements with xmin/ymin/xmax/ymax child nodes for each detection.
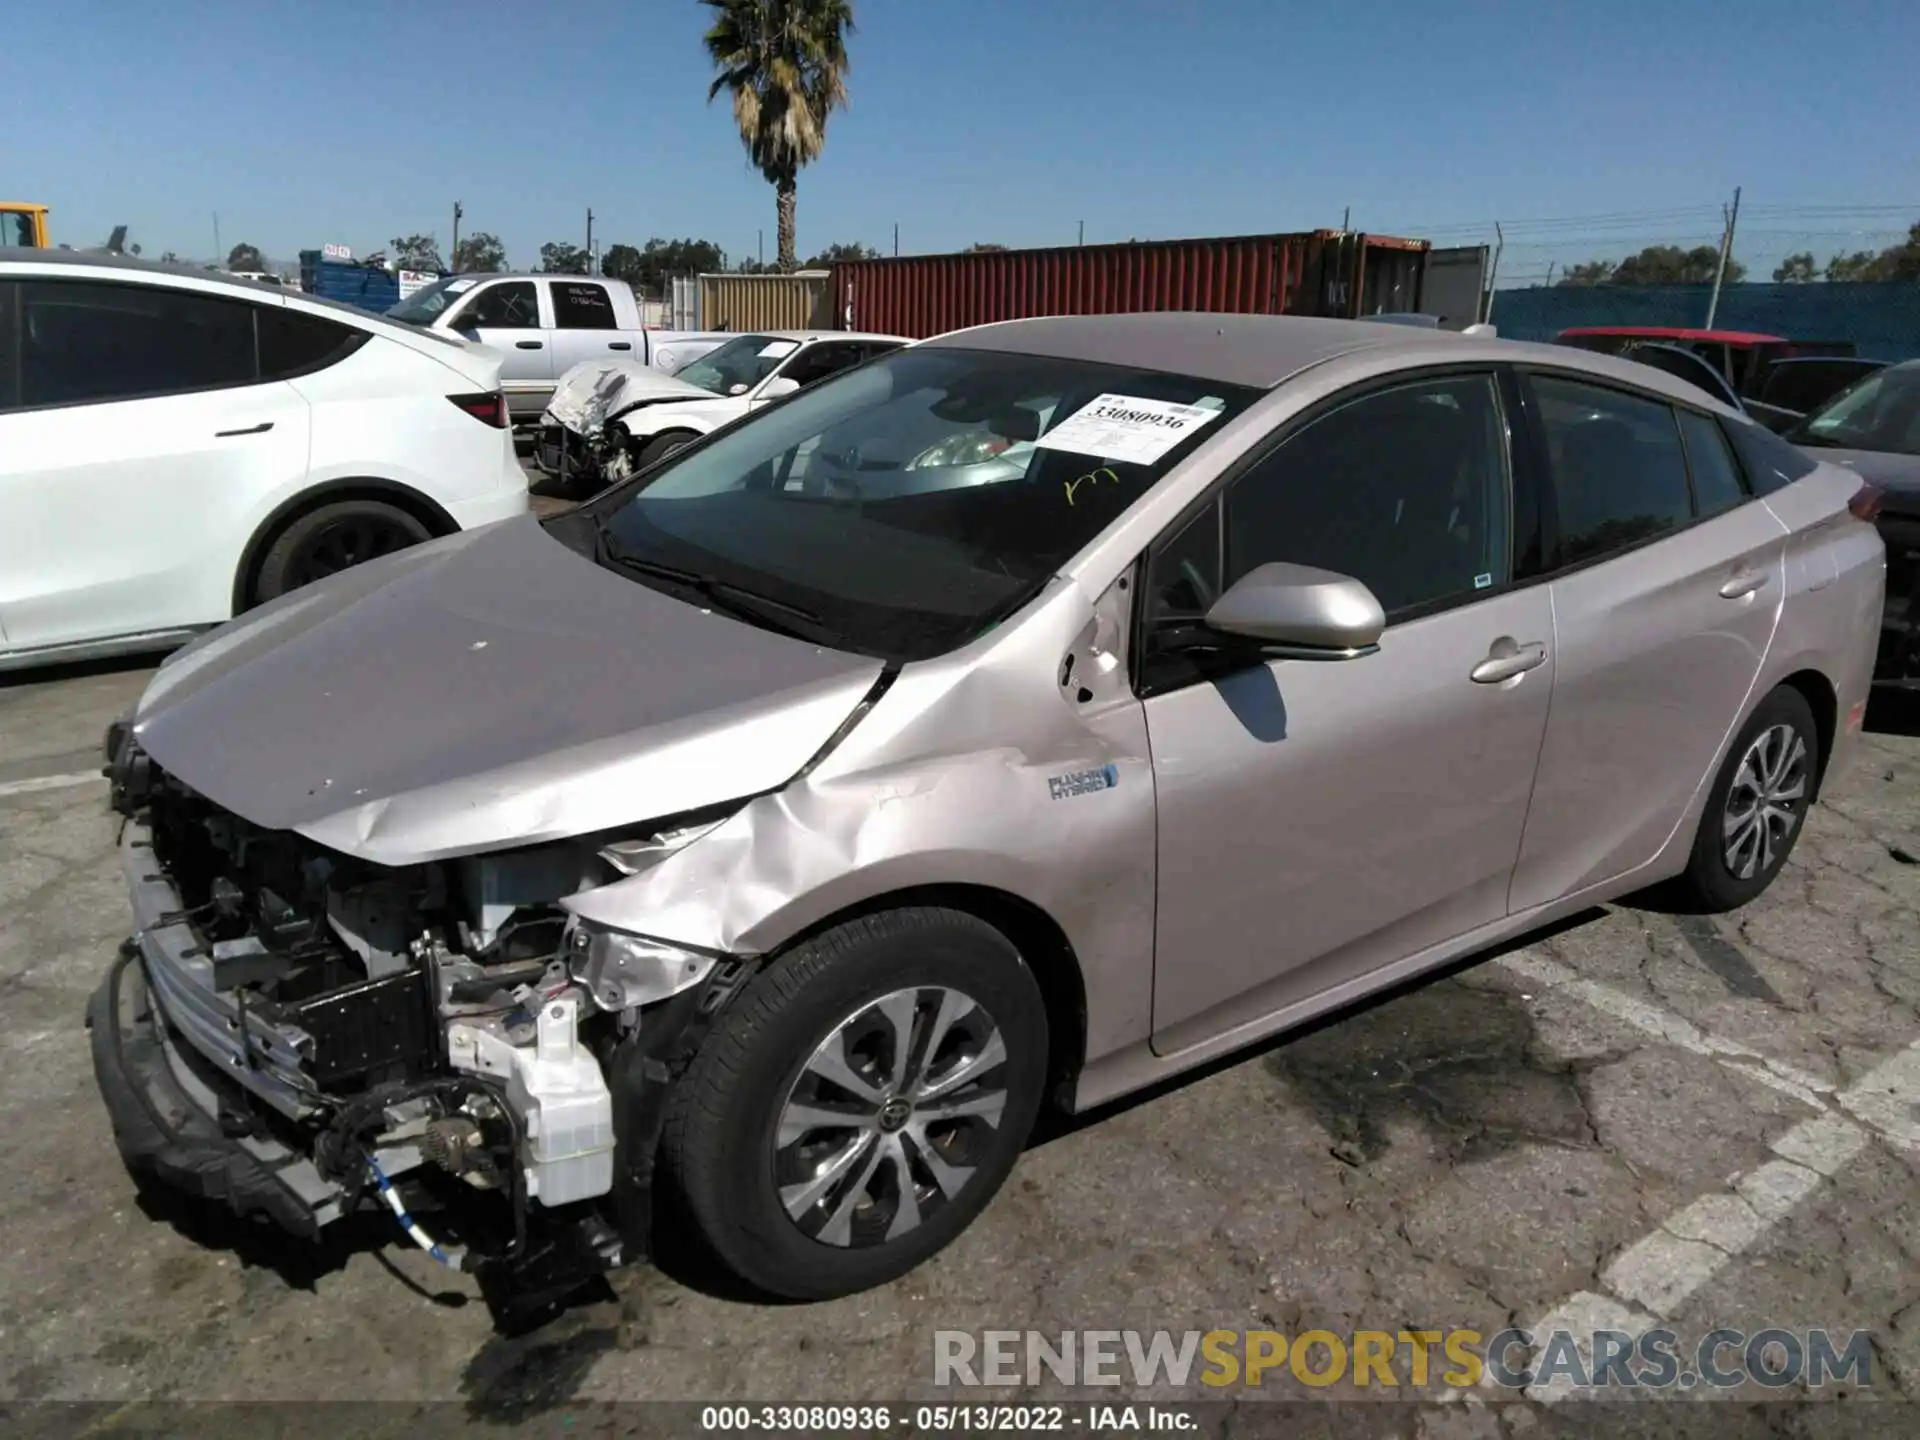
<box><xmin>388</xmin><ymin>275</ymin><xmax>733</xmax><ymax>424</ymax></box>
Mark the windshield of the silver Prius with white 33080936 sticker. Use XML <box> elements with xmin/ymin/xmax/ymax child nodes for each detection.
<box><xmin>576</xmin><ymin>348</ymin><xmax>1260</xmax><ymax>662</ymax></box>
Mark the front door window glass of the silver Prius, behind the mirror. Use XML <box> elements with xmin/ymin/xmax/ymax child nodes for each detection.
<box><xmin>1148</xmin><ymin>374</ymin><xmax>1511</xmax><ymax>620</ymax></box>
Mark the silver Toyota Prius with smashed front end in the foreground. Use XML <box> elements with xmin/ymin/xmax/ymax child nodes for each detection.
<box><xmin>90</xmin><ymin>313</ymin><xmax>1885</xmax><ymax>1306</ymax></box>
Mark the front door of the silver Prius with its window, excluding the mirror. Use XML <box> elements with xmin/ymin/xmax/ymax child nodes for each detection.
<box><xmin>1140</xmin><ymin>372</ymin><xmax>1553</xmax><ymax>1054</ymax></box>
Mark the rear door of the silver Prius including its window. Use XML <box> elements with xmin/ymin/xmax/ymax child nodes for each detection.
<box><xmin>1511</xmin><ymin>372</ymin><xmax>1788</xmax><ymax>912</ymax></box>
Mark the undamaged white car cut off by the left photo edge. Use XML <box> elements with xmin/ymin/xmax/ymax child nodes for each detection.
<box><xmin>0</xmin><ymin>250</ymin><xmax>528</xmax><ymax>670</ymax></box>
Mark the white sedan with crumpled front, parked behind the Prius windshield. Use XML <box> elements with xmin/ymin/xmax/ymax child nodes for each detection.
<box><xmin>534</xmin><ymin>330</ymin><xmax>910</xmax><ymax>482</ymax></box>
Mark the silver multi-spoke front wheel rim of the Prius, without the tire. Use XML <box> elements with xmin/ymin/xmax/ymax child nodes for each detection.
<box><xmin>774</xmin><ymin>985</ymin><xmax>1008</xmax><ymax>1248</ymax></box>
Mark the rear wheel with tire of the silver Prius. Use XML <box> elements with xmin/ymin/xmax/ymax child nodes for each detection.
<box><xmin>1674</xmin><ymin>685</ymin><xmax>1820</xmax><ymax>912</ymax></box>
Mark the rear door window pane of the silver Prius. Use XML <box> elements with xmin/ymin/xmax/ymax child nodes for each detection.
<box><xmin>1530</xmin><ymin>374</ymin><xmax>1693</xmax><ymax>568</ymax></box>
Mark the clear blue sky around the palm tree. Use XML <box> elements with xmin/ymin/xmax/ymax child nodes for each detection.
<box><xmin>0</xmin><ymin>0</ymin><xmax>1920</xmax><ymax>278</ymax></box>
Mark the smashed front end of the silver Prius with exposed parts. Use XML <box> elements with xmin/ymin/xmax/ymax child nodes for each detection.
<box><xmin>88</xmin><ymin>724</ymin><xmax>747</xmax><ymax>1328</ymax></box>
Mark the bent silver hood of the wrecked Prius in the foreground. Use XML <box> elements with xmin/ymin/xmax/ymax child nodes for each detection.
<box><xmin>134</xmin><ymin>516</ymin><xmax>881</xmax><ymax>864</ymax></box>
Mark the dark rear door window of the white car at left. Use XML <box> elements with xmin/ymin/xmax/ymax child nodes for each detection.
<box><xmin>19</xmin><ymin>280</ymin><xmax>259</xmax><ymax>405</ymax></box>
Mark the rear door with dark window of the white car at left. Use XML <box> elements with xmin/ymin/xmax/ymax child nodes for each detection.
<box><xmin>0</xmin><ymin>280</ymin><xmax>311</xmax><ymax>649</ymax></box>
